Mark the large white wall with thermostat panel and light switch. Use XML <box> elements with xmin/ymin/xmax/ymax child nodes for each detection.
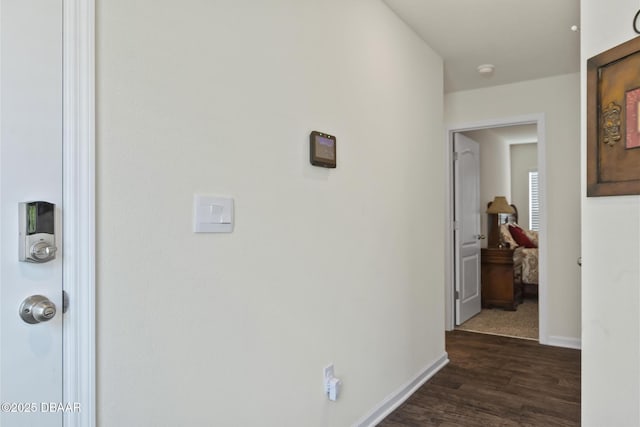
<box><xmin>97</xmin><ymin>0</ymin><xmax>445</xmax><ymax>427</ymax></box>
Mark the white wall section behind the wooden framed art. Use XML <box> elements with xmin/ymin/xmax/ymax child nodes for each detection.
<box><xmin>580</xmin><ymin>0</ymin><xmax>640</xmax><ymax>427</ymax></box>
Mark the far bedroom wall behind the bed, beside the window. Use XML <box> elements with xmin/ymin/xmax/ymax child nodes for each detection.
<box><xmin>509</xmin><ymin>144</ymin><xmax>538</xmax><ymax>228</ymax></box>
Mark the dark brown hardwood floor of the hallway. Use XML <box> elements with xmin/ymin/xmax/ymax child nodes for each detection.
<box><xmin>379</xmin><ymin>331</ymin><xmax>580</xmax><ymax>427</ymax></box>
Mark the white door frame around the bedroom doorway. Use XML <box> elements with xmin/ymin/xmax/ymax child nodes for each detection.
<box><xmin>444</xmin><ymin>113</ymin><xmax>549</xmax><ymax>344</ymax></box>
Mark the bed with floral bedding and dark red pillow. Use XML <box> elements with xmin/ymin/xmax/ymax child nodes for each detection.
<box><xmin>500</xmin><ymin>205</ymin><xmax>538</xmax><ymax>297</ymax></box>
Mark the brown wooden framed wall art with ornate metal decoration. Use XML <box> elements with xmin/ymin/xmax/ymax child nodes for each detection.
<box><xmin>587</xmin><ymin>37</ymin><xmax>640</xmax><ymax>197</ymax></box>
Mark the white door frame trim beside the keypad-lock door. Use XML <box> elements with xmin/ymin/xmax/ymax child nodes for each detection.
<box><xmin>62</xmin><ymin>0</ymin><xmax>96</xmax><ymax>427</ymax></box>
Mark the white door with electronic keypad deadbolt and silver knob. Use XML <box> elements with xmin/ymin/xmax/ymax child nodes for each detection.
<box><xmin>0</xmin><ymin>0</ymin><xmax>64</xmax><ymax>427</ymax></box>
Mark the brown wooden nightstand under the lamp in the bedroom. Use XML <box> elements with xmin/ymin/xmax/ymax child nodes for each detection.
<box><xmin>481</xmin><ymin>248</ymin><xmax>522</xmax><ymax>310</ymax></box>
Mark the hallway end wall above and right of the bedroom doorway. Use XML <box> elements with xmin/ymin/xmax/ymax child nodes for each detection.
<box><xmin>445</xmin><ymin>73</ymin><xmax>580</xmax><ymax>346</ymax></box>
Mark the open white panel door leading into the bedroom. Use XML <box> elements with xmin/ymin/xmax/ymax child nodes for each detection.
<box><xmin>454</xmin><ymin>133</ymin><xmax>481</xmax><ymax>325</ymax></box>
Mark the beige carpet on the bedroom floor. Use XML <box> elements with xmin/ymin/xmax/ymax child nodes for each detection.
<box><xmin>456</xmin><ymin>299</ymin><xmax>538</xmax><ymax>341</ymax></box>
